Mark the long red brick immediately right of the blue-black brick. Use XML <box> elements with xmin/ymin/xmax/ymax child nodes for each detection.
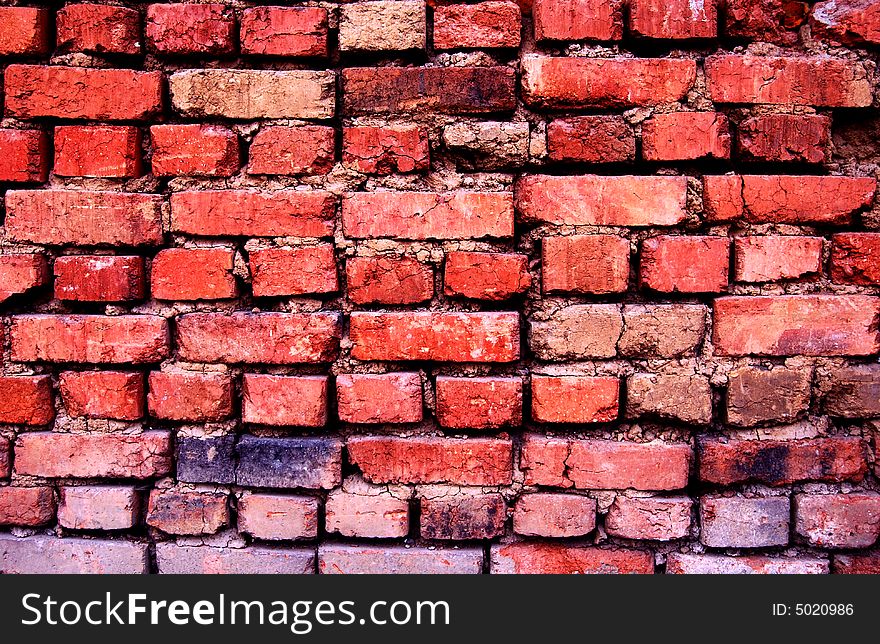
<box><xmin>347</xmin><ymin>436</ymin><xmax>513</xmax><ymax>485</ymax></box>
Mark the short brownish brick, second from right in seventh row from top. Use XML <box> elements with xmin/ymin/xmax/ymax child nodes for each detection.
<box><xmin>727</xmin><ymin>366</ymin><xmax>812</xmax><ymax>427</ymax></box>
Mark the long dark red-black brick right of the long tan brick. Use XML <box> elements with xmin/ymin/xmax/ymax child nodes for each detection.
<box><xmin>342</xmin><ymin>67</ymin><xmax>516</xmax><ymax>115</ymax></box>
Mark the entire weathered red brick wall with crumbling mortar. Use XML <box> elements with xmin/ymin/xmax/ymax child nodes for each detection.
<box><xmin>0</xmin><ymin>0</ymin><xmax>880</xmax><ymax>573</ymax></box>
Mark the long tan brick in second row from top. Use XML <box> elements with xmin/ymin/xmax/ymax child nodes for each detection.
<box><xmin>168</xmin><ymin>69</ymin><xmax>336</xmax><ymax>121</ymax></box>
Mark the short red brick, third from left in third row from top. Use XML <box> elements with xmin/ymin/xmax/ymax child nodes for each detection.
<box><xmin>150</xmin><ymin>125</ymin><xmax>241</xmax><ymax>177</ymax></box>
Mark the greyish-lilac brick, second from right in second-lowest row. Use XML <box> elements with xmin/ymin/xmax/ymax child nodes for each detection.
<box><xmin>700</xmin><ymin>496</ymin><xmax>791</xmax><ymax>548</ymax></box>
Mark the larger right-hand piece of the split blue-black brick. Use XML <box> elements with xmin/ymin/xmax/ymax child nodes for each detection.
<box><xmin>235</xmin><ymin>436</ymin><xmax>342</xmax><ymax>490</ymax></box>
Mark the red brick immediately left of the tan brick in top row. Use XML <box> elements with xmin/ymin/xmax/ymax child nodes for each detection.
<box><xmin>240</xmin><ymin>7</ymin><xmax>327</xmax><ymax>58</ymax></box>
